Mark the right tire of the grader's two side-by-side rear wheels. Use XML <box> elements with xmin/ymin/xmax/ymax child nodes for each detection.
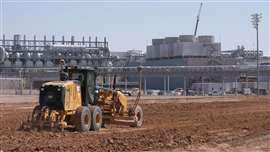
<box><xmin>90</xmin><ymin>106</ymin><xmax>103</xmax><ymax>131</ymax></box>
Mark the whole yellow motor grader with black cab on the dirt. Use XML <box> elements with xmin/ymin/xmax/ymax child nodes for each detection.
<box><xmin>32</xmin><ymin>67</ymin><xmax>143</xmax><ymax>131</ymax></box>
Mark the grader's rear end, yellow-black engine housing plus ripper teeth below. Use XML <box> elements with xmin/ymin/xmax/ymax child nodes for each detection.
<box><xmin>29</xmin><ymin>80</ymin><xmax>82</xmax><ymax>129</ymax></box>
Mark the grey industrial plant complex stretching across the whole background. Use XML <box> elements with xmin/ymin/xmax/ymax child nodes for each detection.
<box><xmin>0</xmin><ymin>34</ymin><xmax>270</xmax><ymax>95</ymax></box>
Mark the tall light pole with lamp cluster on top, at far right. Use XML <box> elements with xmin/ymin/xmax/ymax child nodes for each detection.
<box><xmin>251</xmin><ymin>13</ymin><xmax>262</xmax><ymax>96</ymax></box>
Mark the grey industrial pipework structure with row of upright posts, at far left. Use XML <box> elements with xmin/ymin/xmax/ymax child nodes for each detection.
<box><xmin>0</xmin><ymin>34</ymin><xmax>110</xmax><ymax>68</ymax></box>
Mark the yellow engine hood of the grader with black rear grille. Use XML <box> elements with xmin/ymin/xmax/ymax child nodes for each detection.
<box><xmin>39</xmin><ymin>81</ymin><xmax>81</xmax><ymax>111</ymax></box>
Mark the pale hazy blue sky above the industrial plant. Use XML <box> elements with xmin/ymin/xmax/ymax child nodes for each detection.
<box><xmin>0</xmin><ymin>0</ymin><xmax>270</xmax><ymax>56</ymax></box>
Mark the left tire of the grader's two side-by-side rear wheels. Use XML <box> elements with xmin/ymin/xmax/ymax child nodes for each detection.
<box><xmin>74</xmin><ymin>106</ymin><xmax>91</xmax><ymax>132</ymax></box>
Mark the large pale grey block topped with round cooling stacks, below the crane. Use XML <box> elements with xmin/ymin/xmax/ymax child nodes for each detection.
<box><xmin>146</xmin><ymin>35</ymin><xmax>221</xmax><ymax>64</ymax></box>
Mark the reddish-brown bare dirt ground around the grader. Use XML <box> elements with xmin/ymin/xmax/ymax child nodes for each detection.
<box><xmin>0</xmin><ymin>96</ymin><xmax>270</xmax><ymax>152</ymax></box>
